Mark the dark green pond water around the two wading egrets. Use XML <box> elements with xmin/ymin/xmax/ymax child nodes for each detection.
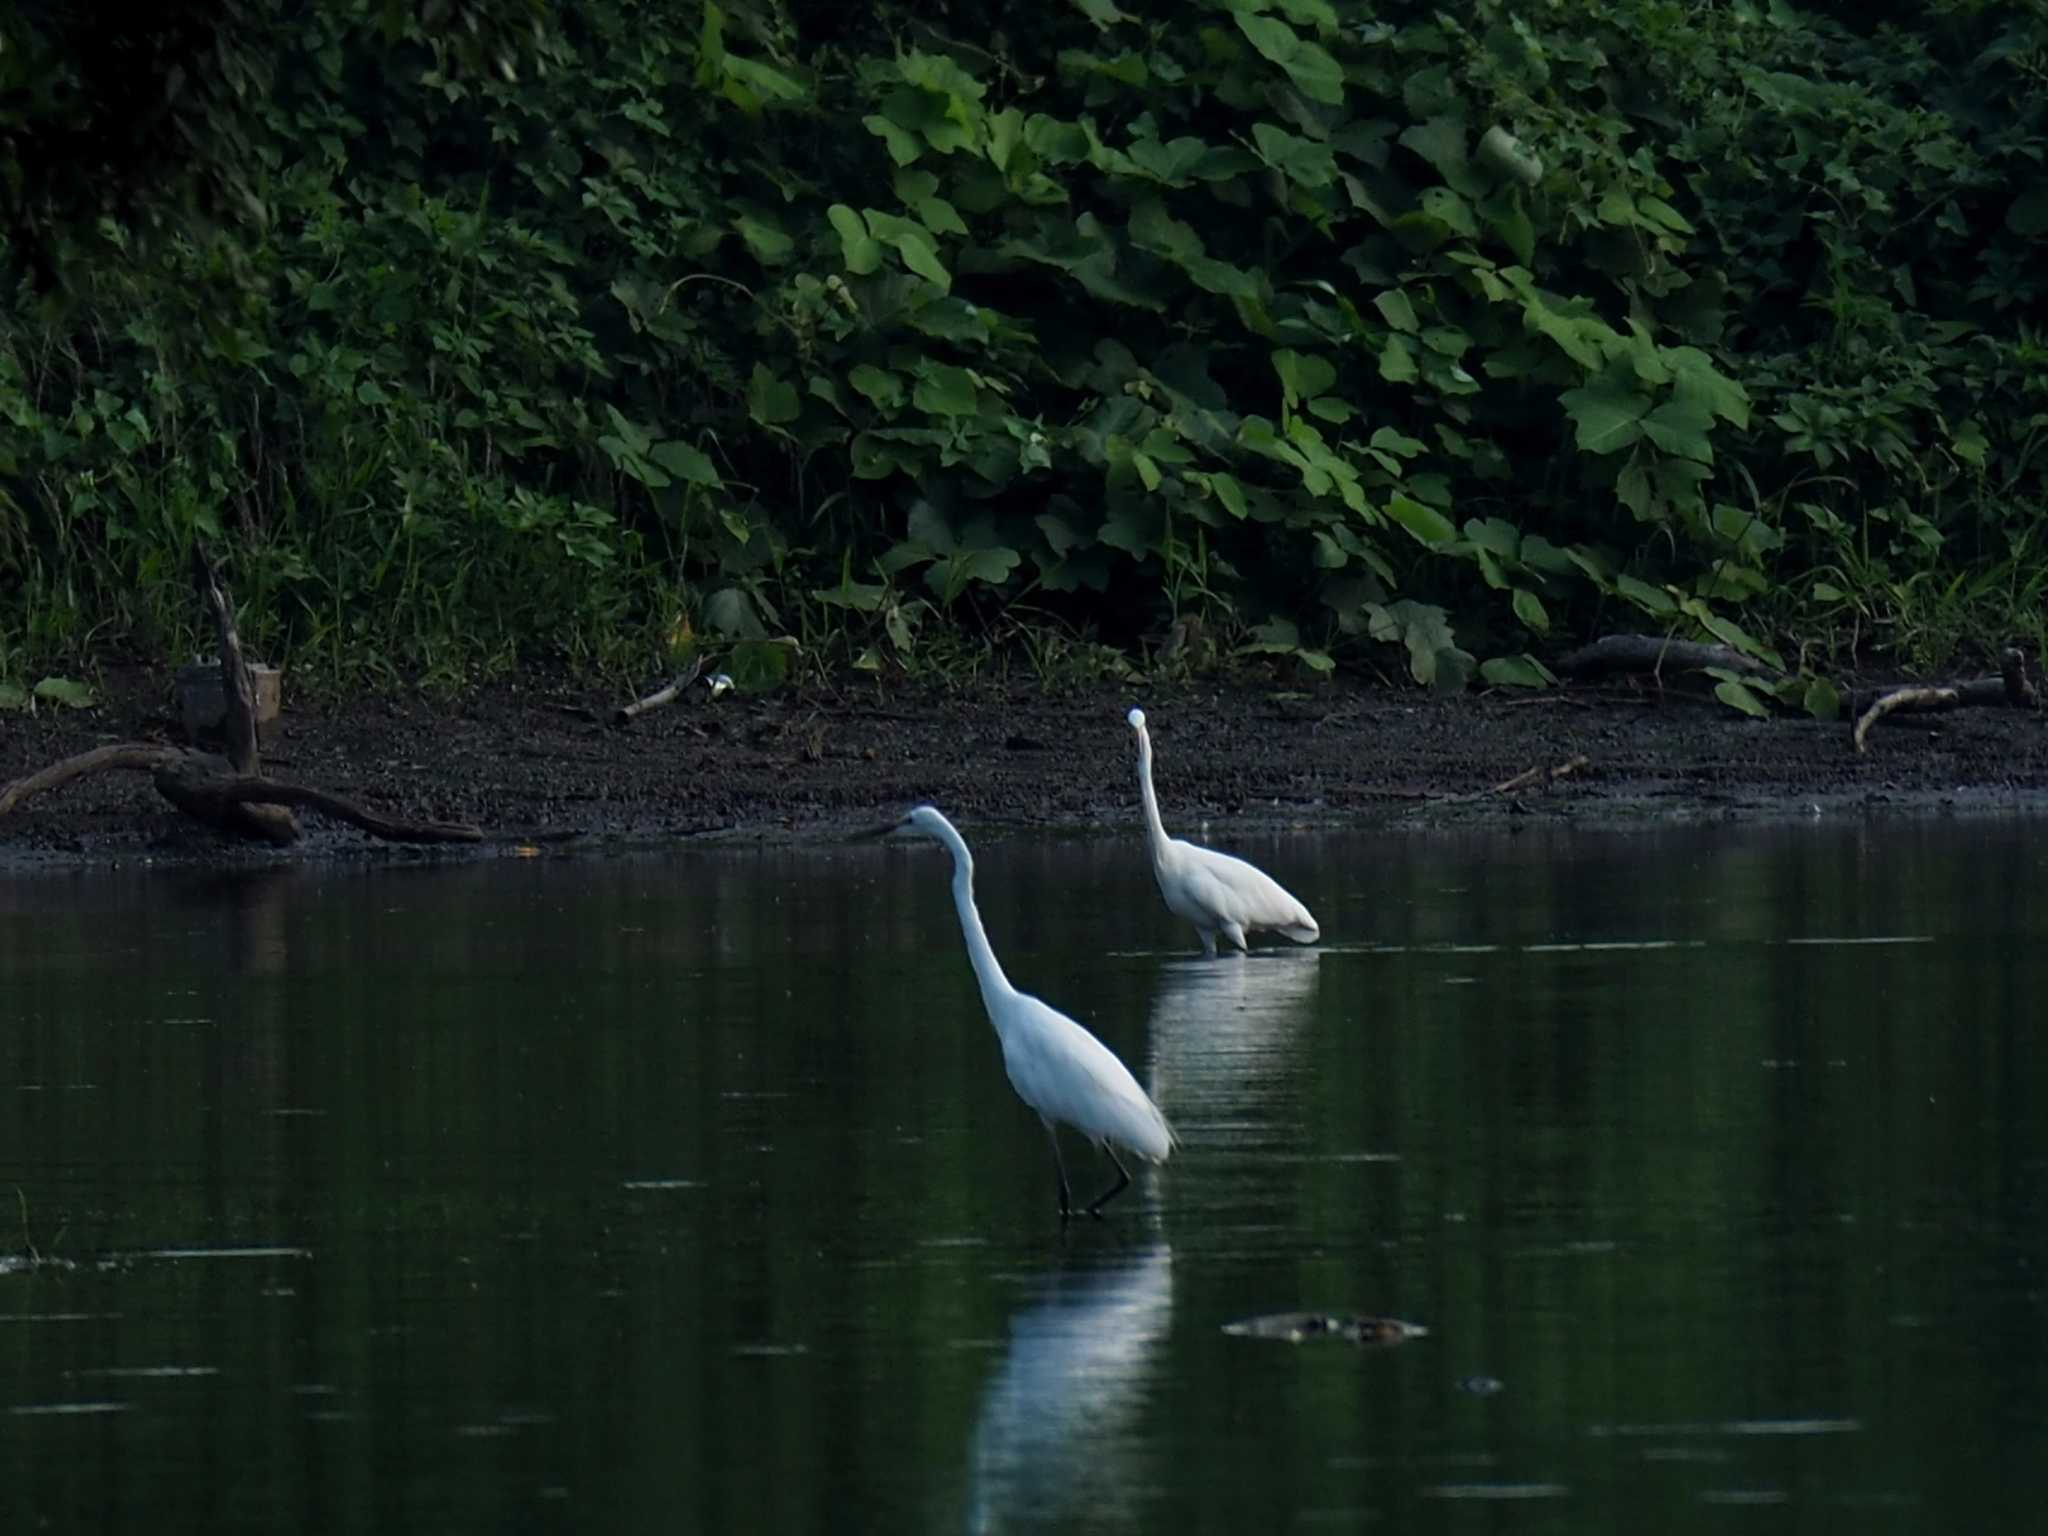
<box><xmin>0</xmin><ymin>821</ymin><xmax>2048</xmax><ymax>1532</ymax></box>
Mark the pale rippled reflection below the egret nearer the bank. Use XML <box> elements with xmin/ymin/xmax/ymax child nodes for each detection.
<box><xmin>1147</xmin><ymin>950</ymin><xmax>1321</xmax><ymax>1139</ymax></box>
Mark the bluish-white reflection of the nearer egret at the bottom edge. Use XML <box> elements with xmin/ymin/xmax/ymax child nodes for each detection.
<box><xmin>967</xmin><ymin>1243</ymin><xmax>1174</xmax><ymax>1532</ymax></box>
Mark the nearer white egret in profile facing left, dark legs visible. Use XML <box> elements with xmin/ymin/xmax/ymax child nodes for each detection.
<box><xmin>883</xmin><ymin>805</ymin><xmax>1176</xmax><ymax>1221</ymax></box>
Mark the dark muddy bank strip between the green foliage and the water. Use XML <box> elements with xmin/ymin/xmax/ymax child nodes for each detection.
<box><xmin>0</xmin><ymin>670</ymin><xmax>2048</xmax><ymax>868</ymax></box>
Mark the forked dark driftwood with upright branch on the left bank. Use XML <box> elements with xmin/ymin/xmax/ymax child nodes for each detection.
<box><xmin>0</xmin><ymin>545</ymin><xmax>483</xmax><ymax>846</ymax></box>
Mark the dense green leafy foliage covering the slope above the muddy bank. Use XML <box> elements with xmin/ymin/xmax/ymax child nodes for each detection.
<box><xmin>0</xmin><ymin>0</ymin><xmax>2048</xmax><ymax>684</ymax></box>
